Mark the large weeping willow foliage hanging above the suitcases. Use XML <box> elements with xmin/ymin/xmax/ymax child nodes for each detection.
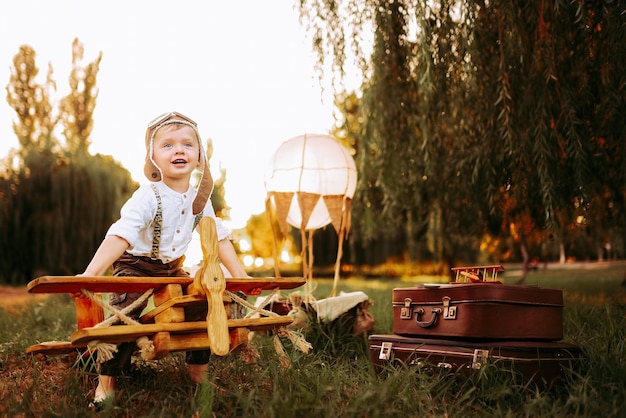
<box><xmin>300</xmin><ymin>0</ymin><xmax>626</xmax><ymax>272</ymax></box>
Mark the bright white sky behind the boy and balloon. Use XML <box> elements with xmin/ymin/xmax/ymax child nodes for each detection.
<box><xmin>0</xmin><ymin>0</ymin><xmax>334</xmax><ymax>235</ymax></box>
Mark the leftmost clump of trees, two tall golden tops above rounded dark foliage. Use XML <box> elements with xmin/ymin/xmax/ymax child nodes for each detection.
<box><xmin>0</xmin><ymin>41</ymin><xmax>136</xmax><ymax>283</ymax></box>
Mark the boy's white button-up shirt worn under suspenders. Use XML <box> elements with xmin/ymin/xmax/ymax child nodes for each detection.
<box><xmin>106</xmin><ymin>181</ymin><xmax>229</xmax><ymax>263</ymax></box>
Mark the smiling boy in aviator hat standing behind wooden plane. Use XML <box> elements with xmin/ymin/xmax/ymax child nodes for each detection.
<box><xmin>72</xmin><ymin>112</ymin><xmax>260</xmax><ymax>404</ymax></box>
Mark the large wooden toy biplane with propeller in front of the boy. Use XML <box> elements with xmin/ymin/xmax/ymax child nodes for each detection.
<box><xmin>26</xmin><ymin>217</ymin><xmax>306</xmax><ymax>360</ymax></box>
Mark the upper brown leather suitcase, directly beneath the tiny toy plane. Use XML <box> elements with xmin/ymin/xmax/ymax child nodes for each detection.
<box><xmin>392</xmin><ymin>282</ymin><xmax>563</xmax><ymax>341</ymax></box>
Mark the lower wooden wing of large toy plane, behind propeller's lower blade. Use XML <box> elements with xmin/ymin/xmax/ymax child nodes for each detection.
<box><xmin>70</xmin><ymin>316</ymin><xmax>293</xmax><ymax>345</ymax></box>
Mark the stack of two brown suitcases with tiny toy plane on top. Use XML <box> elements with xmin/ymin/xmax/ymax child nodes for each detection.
<box><xmin>369</xmin><ymin>265</ymin><xmax>582</xmax><ymax>387</ymax></box>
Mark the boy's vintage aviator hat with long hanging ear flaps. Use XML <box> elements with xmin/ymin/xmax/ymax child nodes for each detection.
<box><xmin>143</xmin><ymin>112</ymin><xmax>213</xmax><ymax>215</ymax></box>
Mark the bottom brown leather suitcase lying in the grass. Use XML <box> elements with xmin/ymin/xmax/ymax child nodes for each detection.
<box><xmin>369</xmin><ymin>334</ymin><xmax>583</xmax><ymax>388</ymax></box>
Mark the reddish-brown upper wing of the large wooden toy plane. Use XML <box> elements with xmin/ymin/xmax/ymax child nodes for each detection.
<box><xmin>27</xmin><ymin>276</ymin><xmax>306</xmax><ymax>293</ymax></box>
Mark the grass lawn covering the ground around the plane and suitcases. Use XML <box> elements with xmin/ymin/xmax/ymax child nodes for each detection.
<box><xmin>0</xmin><ymin>263</ymin><xmax>626</xmax><ymax>417</ymax></box>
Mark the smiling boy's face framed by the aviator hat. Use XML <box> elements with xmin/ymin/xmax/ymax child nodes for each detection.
<box><xmin>152</xmin><ymin>125</ymin><xmax>200</xmax><ymax>183</ymax></box>
